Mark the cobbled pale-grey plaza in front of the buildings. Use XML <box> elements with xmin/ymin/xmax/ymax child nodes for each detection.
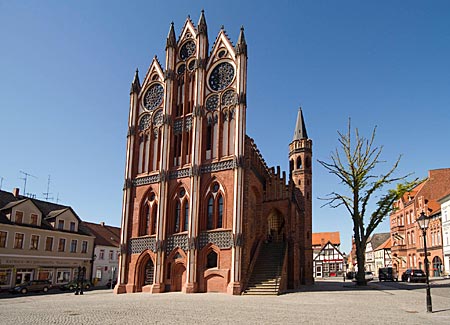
<box><xmin>0</xmin><ymin>280</ymin><xmax>450</xmax><ymax>324</ymax></box>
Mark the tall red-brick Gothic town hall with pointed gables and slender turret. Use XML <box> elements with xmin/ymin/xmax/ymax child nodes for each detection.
<box><xmin>115</xmin><ymin>11</ymin><xmax>313</xmax><ymax>295</ymax></box>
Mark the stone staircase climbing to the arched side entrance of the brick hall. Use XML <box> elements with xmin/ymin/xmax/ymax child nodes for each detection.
<box><xmin>243</xmin><ymin>242</ymin><xmax>284</xmax><ymax>295</ymax></box>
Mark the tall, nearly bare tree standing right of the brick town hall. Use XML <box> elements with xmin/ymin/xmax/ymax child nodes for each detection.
<box><xmin>318</xmin><ymin>120</ymin><xmax>419</xmax><ymax>285</ymax></box>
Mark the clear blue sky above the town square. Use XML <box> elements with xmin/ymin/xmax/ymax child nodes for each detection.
<box><xmin>0</xmin><ymin>0</ymin><xmax>450</xmax><ymax>252</ymax></box>
